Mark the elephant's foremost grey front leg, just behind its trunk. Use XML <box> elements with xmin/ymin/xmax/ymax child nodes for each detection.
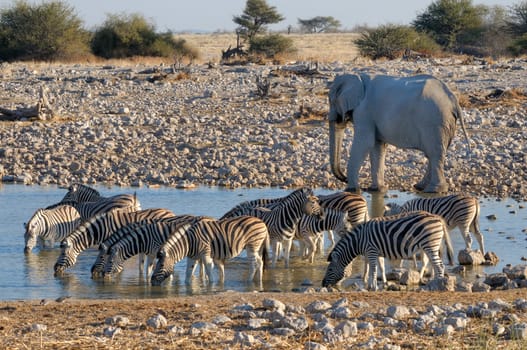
<box><xmin>346</xmin><ymin>132</ymin><xmax>375</xmax><ymax>192</ymax></box>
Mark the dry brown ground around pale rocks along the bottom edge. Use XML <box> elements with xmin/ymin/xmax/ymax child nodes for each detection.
<box><xmin>0</xmin><ymin>289</ymin><xmax>527</xmax><ymax>349</ymax></box>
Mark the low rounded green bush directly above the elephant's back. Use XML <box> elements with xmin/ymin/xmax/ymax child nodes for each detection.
<box><xmin>354</xmin><ymin>24</ymin><xmax>439</xmax><ymax>59</ymax></box>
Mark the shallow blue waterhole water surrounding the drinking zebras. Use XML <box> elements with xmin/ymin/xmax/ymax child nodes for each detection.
<box><xmin>0</xmin><ymin>184</ymin><xmax>527</xmax><ymax>300</ymax></box>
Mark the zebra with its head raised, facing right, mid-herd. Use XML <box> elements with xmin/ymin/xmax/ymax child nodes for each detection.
<box><xmin>245</xmin><ymin>188</ymin><xmax>323</xmax><ymax>268</ymax></box>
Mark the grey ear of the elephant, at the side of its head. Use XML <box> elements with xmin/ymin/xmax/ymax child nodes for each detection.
<box><xmin>329</xmin><ymin>74</ymin><xmax>364</xmax><ymax>120</ymax></box>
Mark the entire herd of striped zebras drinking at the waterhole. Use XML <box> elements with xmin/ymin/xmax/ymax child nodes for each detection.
<box><xmin>24</xmin><ymin>184</ymin><xmax>484</xmax><ymax>290</ymax></box>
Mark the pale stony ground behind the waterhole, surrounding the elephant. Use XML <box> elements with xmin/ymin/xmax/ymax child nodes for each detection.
<box><xmin>0</xmin><ymin>57</ymin><xmax>527</xmax><ymax>200</ymax></box>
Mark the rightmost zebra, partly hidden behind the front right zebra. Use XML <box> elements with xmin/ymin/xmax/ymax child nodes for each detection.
<box><xmin>384</xmin><ymin>194</ymin><xmax>485</xmax><ymax>255</ymax></box>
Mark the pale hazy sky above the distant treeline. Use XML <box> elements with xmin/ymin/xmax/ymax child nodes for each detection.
<box><xmin>0</xmin><ymin>0</ymin><xmax>521</xmax><ymax>32</ymax></box>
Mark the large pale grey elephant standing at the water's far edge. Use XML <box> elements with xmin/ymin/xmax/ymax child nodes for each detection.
<box><xmin>329</xmin><ymin>74</ymin><xmax>470</xmax><ymax>192</ymax></box>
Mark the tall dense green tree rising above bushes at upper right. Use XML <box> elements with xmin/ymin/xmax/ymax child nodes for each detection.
<box><xmin>412</xmin><ymin>0</ymin><xmax>487</xmax><ymax>50</ymax></box>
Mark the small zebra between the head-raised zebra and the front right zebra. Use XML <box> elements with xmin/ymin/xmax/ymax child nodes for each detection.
<box><xmin>295</xmin><ymin>208</ymin><xmax>352</xmax><ymax>263</ymax></box>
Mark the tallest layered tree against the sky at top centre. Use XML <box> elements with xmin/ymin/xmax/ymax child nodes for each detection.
<box><xmin>232</xmin><ymin>0</ymin><xmax>284</xmax><ymax>41</ymax></box>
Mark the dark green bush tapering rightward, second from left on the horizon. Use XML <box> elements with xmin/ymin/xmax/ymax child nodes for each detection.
<box><xmin>91</xmin><ymin>14</ymin><xmax>198</xmax><ymax>61</ymax></box>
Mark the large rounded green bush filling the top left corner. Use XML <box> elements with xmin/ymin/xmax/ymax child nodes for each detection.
<box><xmin>0</xmin><ymin>1</ymin><xmax>89</xmax><ymax>61</ymax></box>
